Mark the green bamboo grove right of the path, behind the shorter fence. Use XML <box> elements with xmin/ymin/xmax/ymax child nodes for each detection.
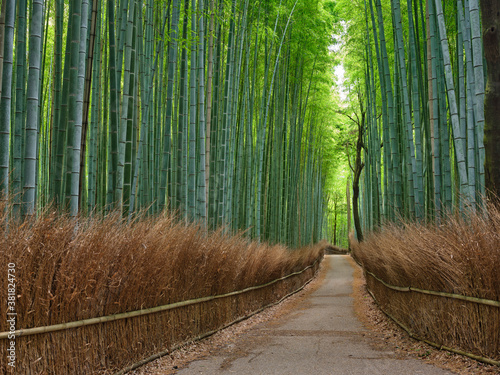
<box><xmin>342</xmin><ymin>0</ymin><xmax>485</xmax><ymax>230</ymax></box>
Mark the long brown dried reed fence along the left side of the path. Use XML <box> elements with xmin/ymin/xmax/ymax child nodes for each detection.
<box><xmin>0</xmin><ymin>210</ymin><xmax>326</xmax><ymax>374</ymax></box>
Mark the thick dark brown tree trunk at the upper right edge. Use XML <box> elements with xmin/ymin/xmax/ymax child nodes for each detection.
<box><xmin>481</xmin><ymin>0</ymin><xmax>500</xmax><ymax>198</ymax></box>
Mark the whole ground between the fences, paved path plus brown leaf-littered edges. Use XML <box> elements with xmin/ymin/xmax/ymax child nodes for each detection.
<box><xmin>133</xmin><ymin>255</ymin><xmax>499</xmax><ymax>375</ymax></box>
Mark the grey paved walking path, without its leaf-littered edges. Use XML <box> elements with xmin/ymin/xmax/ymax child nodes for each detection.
<box><xmin>177</xmin><ymin>255</ymin><xmax>452</xmax><ymax>375</ymax></box>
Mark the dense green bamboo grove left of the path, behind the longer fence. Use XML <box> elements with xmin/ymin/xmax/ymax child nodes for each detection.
<box><xmin>0</xmin><ymin>0</ymin><xmax>332</xmax><ymax>246</ymax></box>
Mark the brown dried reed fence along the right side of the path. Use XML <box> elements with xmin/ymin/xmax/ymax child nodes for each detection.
<box><xmin>351</xmin><ymin>206</ymin><xmax>500</xmax><ymax>365</ymax></box>
